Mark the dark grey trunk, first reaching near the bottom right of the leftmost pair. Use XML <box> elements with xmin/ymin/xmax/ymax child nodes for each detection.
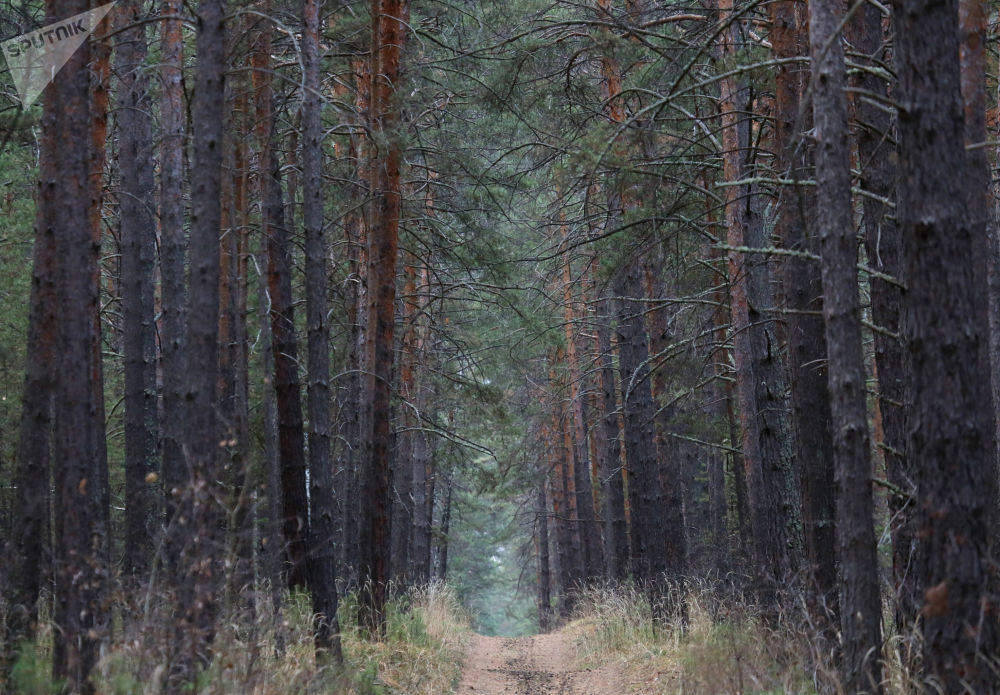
<box><xmin>177</xmin><ymin>0</ymin><xmax>226</xmax><ymax>682</ymax></box>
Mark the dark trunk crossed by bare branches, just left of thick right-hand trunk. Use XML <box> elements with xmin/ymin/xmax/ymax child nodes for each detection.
<box><xmin>848</xmin><ymin>0</ymin><xmax>919</xmax><ymax>635</ymax></box>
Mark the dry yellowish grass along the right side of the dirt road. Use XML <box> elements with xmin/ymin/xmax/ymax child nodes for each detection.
<box><xmin>567</xmin><ymin>583</ymin><xmax>921</xmax><ymax>695</ymax></box>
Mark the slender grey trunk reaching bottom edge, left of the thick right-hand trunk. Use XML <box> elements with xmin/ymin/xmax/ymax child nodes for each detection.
<box><xmin>809</xmin><ymin>3</ymin><xmax>882</xmax><ymax>693</ymax></box>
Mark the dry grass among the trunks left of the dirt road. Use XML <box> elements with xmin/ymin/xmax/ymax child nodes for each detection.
<box><xmin>3</xmin><ymin>584</ymin><xmax>471</xmax><ymax>695</ymax></box>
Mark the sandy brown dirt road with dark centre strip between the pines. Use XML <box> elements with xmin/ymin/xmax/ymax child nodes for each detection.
<box><xmin>456</xmin><ymin>633</ymin><xmax>624</xmax><ymax>695</ymax></box>
